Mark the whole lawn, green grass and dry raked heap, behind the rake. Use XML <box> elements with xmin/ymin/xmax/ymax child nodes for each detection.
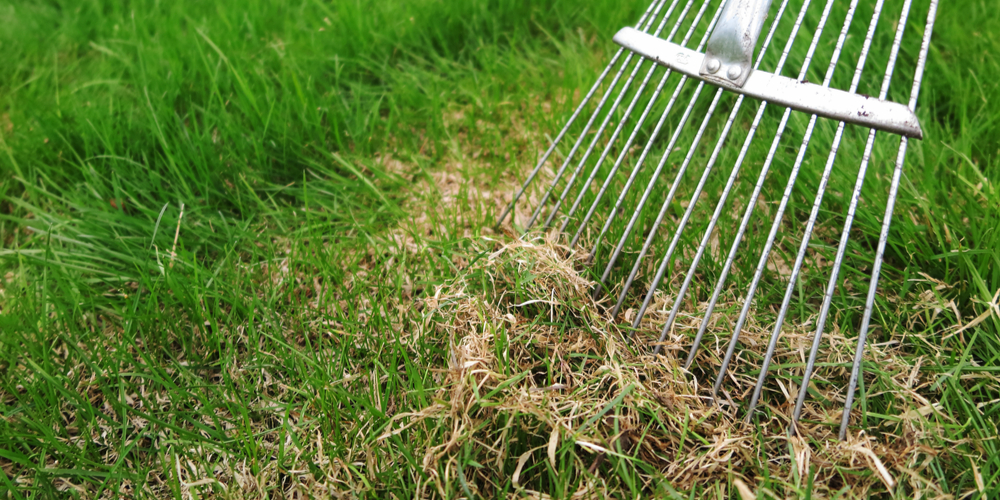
<box><xmin>0</xmin><ymin>0</ymin><xmax>1000</xmax><ymax>499</ymax></box>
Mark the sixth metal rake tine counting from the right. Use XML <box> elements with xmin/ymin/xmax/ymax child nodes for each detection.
<box><xmin>648</xmin><ymin>2</ymin><xmax>796</xmax><ymax>354</ymax></box>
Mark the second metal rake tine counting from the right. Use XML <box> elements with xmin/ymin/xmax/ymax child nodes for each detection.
<box><xmin>788</xmin><ymin>0</ymin><xmax>912</xmax><ymax>430</ymax></box>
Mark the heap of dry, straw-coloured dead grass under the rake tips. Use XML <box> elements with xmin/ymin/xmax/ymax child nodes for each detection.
<box><xmin>400</xmin><ymin>236</ymin><xmax>940</xmax><ymax>497</ymax></box>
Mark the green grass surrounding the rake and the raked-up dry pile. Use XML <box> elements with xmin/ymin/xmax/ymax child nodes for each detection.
<box><xmin>0</xmin><ymin>0</ymin><xmax>1000</xmax><ymax>498</ymax></box>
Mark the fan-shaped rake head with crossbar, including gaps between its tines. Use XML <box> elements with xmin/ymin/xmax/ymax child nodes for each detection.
<box><xmin>497</xmin><ymin>0</ymin><xmax>937</xmax><ymax>439</ymax></box>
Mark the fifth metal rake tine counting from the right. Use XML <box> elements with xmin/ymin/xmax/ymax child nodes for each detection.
<box><xmin>633</xmin><ymin>0</ymin><xmax>833</xmax><ymax>340</ymax></box>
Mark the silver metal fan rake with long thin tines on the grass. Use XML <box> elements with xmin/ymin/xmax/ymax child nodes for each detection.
<box><xmin>497</xmin><ymin>0</ymin><xmax>937</xmax><ymax>439</ymax></box>
